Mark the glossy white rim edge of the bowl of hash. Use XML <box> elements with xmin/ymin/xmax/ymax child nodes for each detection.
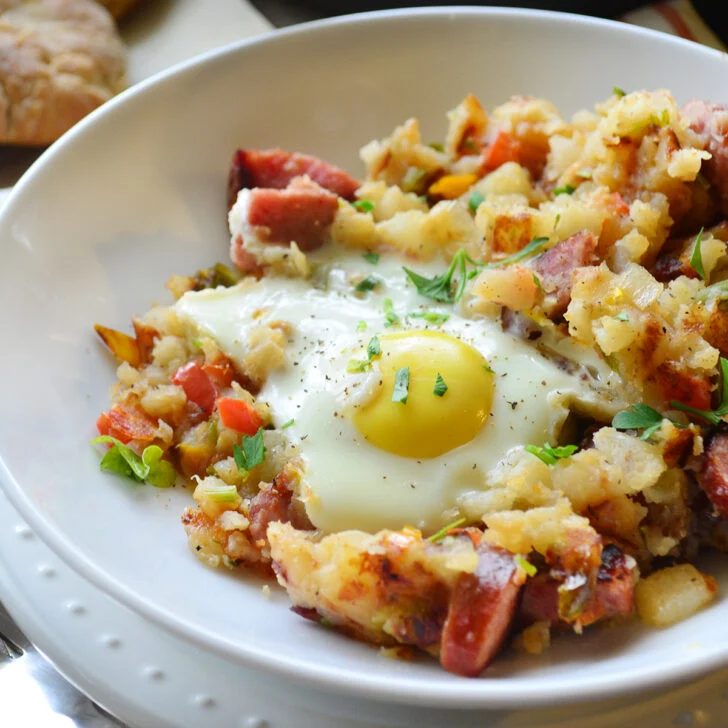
<box><xmin>0</xmin><ymin>5</ymin><xmax>728</xmax><ymax>708</ymax></box>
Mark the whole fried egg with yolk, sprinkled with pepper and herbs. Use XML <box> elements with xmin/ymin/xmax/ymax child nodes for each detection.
<box><xmin>176</xmin><ymin>246</ymin><xmax>608</xmax><ymax>532</ymax></box>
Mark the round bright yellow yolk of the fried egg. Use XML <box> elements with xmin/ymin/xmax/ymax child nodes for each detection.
<box><xmin>352</xmin><ymin>331</ymin><xmax>494</xmax><ymax>458</ymax></box>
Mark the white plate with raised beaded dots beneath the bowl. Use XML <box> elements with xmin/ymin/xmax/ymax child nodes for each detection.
<box><xmin>0</xmin><ymin>492</ymin><xmax>728</xmax><ymax>728</ymax></box>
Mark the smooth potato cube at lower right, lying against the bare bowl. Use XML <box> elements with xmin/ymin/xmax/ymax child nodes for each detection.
<box><xmin>635</xmin><ymin>564</ymin><xmax>717</xmax><ymax>627</ymax></box>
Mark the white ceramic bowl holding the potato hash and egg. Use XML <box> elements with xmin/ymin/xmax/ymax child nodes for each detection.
<box><xmin>0</xmin><ymin>8</ymin><xmax>728</xmax><ymax>707</ymax></box>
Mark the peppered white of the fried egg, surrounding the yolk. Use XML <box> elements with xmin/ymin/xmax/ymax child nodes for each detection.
<box><xmin>176</xmin><ymin>246</ymin><xmax>608</xmax><ymax>532</ymax></box>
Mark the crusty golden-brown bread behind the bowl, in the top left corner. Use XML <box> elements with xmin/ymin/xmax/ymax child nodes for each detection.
<box><xmin>0</xmin><ymin>0</ymin><xmax>126</xmax><ymax>145</ymax></box>
